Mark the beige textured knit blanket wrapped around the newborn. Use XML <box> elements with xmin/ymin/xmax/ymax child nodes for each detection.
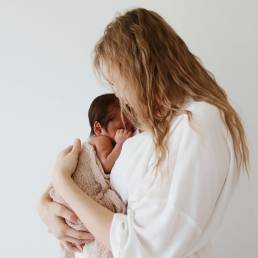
<box><xmin>49</xmin><ymin>142</ymin><xmax>126</xmax><ymax>258</ymax></box>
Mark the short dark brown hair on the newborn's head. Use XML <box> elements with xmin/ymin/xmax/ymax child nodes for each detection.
<box><xmin>88</xmin><ymin>93</ymin><xmax>121</xmax><ymax>136</ymax></box>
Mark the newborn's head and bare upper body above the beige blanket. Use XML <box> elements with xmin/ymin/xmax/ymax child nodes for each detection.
<box><xmin>88</xmin><ymin>93</ymin><xmax>135</xmax><ymax>173</ymax></box>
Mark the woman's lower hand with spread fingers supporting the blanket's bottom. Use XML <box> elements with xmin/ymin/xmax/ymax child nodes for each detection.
<box><xmin>37</xmin><ymin>185</ymin><xmax>94</xmax><ymax>251</ymax></box>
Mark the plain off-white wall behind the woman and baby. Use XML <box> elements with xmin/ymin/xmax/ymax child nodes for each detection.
<box><xmin>0</xmin><ymin>0</ymin><xmax>258</xmax><ymax>258</ymax></box>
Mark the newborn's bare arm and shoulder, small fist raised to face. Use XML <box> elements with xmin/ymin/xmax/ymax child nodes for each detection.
<box><xmin>93</xmin><ymin>129</ymin><xmax>132</xmax><ymax>173</ymax></box>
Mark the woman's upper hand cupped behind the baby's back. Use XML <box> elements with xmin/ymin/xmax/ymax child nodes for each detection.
<box><xmin>52</xmin><ymin>139</ymin><xmax>81</xmax><ymax>192</ymax></box>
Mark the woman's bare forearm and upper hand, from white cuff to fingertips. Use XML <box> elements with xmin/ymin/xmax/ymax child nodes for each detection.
<box><xmin>52</xmin><ymin>140</ymin><xmax>113</xmax><ymax>251</ymax></box>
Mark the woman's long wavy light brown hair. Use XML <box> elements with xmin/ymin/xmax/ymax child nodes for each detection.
<box><xmin>94</xmin><ymin>8</ymin><xmax>249</xmax><ymax>175</ymax></box>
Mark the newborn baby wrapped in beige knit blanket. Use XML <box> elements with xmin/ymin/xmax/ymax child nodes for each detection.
<box><xmin>49</xmin><ymin>94</ymin><xmax>134</xmax><ymax>258</ymax></box>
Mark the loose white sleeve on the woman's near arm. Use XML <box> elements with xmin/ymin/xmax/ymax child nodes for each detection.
<box><xmin>110</xmin><ymin>107</ymin><xmax>230</xmax><ymax>258</ymax></box>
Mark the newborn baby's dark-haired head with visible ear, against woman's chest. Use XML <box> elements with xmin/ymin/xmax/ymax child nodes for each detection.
<box><xmin>88</xmin><ymin>93</ymin><xmax>134</xmax><ymax>139</ymax></box>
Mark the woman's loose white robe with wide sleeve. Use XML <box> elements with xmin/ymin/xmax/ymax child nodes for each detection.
<box><xmin>110</xmin><ymin>100</ymin><xmax>237</xmax><ymax>258</ymax></box>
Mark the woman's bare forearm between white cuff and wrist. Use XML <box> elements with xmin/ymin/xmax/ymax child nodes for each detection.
<box><xmin>57</xmin><ymin>178</ymin><xmax>114</xmax><ymax>249</ymax></box>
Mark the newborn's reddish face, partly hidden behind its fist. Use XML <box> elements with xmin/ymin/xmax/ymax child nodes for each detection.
<box><xmin>105</xmin><ymin>112</ymin><xmax>134</xmax><ymax>140</ymax></box>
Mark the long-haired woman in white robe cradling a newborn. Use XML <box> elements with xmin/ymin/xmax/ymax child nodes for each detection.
<box><xmin>39</xmin><ymin>9</ymin><xmax>248</xmax><ymax>258</ymax></box>
